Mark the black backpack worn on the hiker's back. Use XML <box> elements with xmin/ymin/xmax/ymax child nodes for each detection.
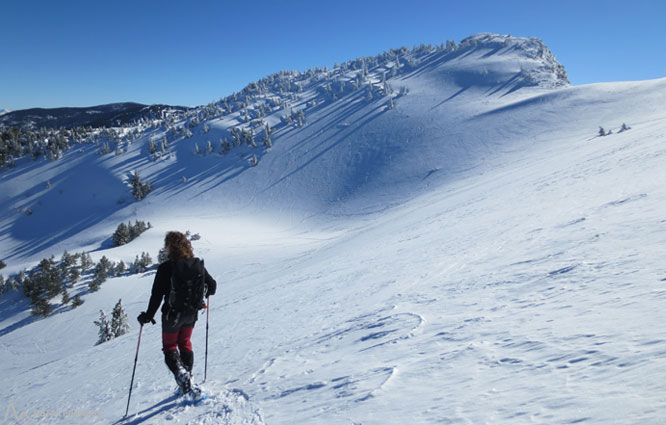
<box><xmin>168</xmin><ymin>258</ymin><xmax>208</xmax><ymax>312</ymax></box>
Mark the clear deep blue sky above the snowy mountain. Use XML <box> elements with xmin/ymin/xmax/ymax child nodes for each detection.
<box><xmin>0</xmin><ymin>0</ymin><xmax>666</xmax><ymax>110</ymax></box>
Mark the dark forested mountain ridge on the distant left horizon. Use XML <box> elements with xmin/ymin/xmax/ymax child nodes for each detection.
<box><xmin>0</xmin><ymin>102</ymin><xmax>189</xmax><ymax>129</ymax></box>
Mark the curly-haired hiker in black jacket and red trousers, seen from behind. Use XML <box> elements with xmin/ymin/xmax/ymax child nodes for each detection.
<box><xmin>137</xmin><ymin>232</ymin><xmax>217</xmax><ymax>396</ymax></box>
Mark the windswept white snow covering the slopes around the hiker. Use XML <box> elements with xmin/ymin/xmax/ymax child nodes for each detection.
<box><xmin>0</xmin><ymin>34</ymin><xmax>666</xmax><ymax>425</ymax></box>
